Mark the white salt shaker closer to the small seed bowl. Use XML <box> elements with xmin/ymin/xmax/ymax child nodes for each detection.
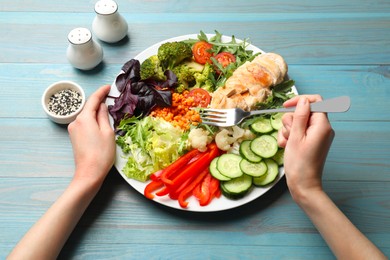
<box><xmin>66</xmin><ymin>28</ymin><xmax>103</xmax><ymax>70</ymax></box>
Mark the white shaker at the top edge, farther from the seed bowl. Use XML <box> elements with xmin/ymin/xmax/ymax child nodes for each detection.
<box><xmin>92</xmin><ymin>0</ymin><xmax>128</xmax><ymax>43</ymax></box>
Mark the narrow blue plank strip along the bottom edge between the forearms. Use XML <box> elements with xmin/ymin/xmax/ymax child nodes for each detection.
<box><xmin>0</xmin><ymin>244</ymin><xmax>334</xmax><ymax>260</ymax></box>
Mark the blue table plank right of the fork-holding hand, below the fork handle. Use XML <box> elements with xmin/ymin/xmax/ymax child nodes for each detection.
<box><xmin>324</xmin><ymin>122</ymin><xmax>390</xmax><ymax>182</ymax></box>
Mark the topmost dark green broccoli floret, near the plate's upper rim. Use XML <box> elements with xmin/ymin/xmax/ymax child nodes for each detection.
<box><xmin>157</xmin><ymin>42</ymin><xmax>192</xmax><ymax>70</ymax></box>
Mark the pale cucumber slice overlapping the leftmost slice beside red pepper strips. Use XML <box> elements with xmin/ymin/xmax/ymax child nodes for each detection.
<box><xmin>217</xmin><ymin>153</ymin><xmax>244</xmax><ymax>179</ymax></box>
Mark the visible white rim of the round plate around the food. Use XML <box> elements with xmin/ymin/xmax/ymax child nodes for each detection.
<box><xmin>107</xmin><ymin>34</ymin><xmax>295</xmax><ymax>212</ymax></box>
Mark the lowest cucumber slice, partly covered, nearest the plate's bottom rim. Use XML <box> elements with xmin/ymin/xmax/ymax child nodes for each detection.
<box><xmin>221</xmin><ymin>174</ymin><xmax>253</xmax><ymax>199</ymax></box>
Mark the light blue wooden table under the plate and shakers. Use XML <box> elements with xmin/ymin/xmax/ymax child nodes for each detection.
<box><xmin>0</xmin><ymin>0</ymin><xmax>390</xmax><ymax>259</ymax></box>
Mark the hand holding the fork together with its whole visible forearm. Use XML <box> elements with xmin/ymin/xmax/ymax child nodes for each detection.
<box><xmin>278</xmin><ymin>95</ymin><xmax>386</xmax><ymax>259</ymax></box>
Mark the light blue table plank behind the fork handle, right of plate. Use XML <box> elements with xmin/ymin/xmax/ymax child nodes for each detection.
<box><xmin>289</xmin><ymin>64</ymin><xmax>390</xmax><ymax>121</ymax></box>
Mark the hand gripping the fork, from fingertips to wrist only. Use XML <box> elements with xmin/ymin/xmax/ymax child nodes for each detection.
<box><xmin>278</xmin><ymin>95</ymin><xmax>334</xmax><ymax>203</ymax></box>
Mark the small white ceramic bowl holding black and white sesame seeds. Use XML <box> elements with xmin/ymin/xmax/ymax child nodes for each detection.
<box><xmin>42</xmin><ymin>81</ymin><xmax>86</xmax><ymax>124</ymax></box>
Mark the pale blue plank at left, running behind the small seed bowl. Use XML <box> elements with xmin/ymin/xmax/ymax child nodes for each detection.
<box><xmin>0</xmin><ymin>63</ymin><xmax>122</xmax><ymax>118</ymax></box>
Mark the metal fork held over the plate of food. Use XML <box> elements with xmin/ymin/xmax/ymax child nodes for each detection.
<box><xmin>199</xmin><ymin>96</ymin><xmax>351</xmax><ymax>127</ymax></box>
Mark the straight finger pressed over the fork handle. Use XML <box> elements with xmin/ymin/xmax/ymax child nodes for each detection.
<box><xmin>290</xmin><ymin>97</ymin><xmax>310</xmax><ymax>139</ymax></box>
